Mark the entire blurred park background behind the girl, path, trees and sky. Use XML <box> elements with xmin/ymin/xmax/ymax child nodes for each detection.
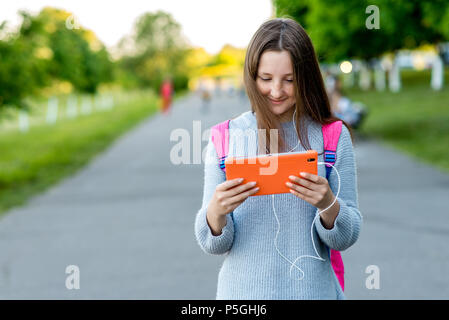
<box><xmin>0</xmin><ymin>0</ymin><xmax>449</xmax><ymax>299</ymax></box>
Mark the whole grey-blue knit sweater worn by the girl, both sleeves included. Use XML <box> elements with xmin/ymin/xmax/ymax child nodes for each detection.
<box><xmin>195</xmin><ymin>111</ymin><xmax>362</xmax><ymax>300</ymax></box>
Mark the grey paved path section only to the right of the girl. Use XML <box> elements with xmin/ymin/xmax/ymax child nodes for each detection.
<box><xmin>342</xmin><ymin>134</ymin><xmax>449</xmax><ymax>299</ymax></box>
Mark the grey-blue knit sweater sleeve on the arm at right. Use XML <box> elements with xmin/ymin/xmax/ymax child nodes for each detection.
<box><xmin>315</xmin><ymin>125</ymin><xmax>362</xmax><ymax>251</ymax></box>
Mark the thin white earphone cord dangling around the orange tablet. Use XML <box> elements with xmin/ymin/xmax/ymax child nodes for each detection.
<box><xmin>267</xmin><ymin>109</ymin><xmax>340</xmax><ymax>280</ymax></box>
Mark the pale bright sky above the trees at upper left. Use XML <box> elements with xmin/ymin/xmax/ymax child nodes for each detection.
<box><xmin>0</xmin><ymin>0</ymin><xmax>272</xmax><ymax>54</ymax></box>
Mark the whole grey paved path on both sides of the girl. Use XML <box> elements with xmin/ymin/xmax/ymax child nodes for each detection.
<box><xmin>0</xmin><ymin>91</ymin><xmax>449</xmax><ymax>299</ymax></box>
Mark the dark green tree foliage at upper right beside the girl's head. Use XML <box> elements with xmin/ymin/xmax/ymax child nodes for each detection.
<box><xmin>273</xmin><ymin>0</ymin><xmax>449</xmax><ymax>62</ymax></box>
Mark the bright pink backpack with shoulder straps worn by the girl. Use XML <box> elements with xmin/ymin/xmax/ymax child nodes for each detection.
<box><xmin>211</xmin><ymin>120</ymin><xmax>345</xmax><ymax>291</ymax></box>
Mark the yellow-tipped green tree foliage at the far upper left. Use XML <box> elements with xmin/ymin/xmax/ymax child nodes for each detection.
<box><xmin>0</xmin><ymin>7</ymin><xmax>113</xmax><ymax>109</ymax></box>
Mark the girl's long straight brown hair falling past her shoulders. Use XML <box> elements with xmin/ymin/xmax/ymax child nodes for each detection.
<box><xmin>244</xmin><ymin>18</ymin><xmax>352</xmax><ymax>153</ymax></box>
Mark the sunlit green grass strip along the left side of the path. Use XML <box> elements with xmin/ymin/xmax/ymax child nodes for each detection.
<box><xmin>0</xmin><ymin>90</ymin><xmax>168</xmax><ymax>214</ymax></box>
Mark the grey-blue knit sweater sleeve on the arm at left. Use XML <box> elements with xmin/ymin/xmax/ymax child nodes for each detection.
<box><xmin>195</xmin><ymin>132</ymin><xmax>234</xmax><ymax>255</ymax></box>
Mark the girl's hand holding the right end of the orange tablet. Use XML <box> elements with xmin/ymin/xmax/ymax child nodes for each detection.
<box><xmin>285</xmin><ymin>172</ymin><xmax>335</xmax><ymax>211</ymax></box>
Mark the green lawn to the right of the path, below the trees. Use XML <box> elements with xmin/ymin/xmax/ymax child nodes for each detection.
<box><xmin>346</xmin><ymin>70</ymin><xmax>449</xmax><ymax>173</ymax></box>
